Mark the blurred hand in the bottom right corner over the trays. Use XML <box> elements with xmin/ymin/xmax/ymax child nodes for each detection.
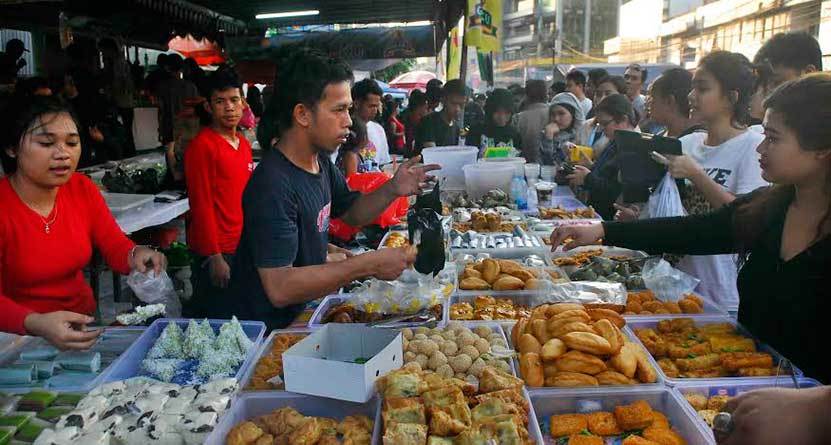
<box><xmin>716</xmin><ymin>387</ymin><xmax>831</xmax><ymax>445</ymax></box>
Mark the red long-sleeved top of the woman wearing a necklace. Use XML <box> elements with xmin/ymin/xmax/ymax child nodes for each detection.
<box><xmin>0</xmin><ymin>174</ymin><xmax>134</xmax><ymax>334</ymax></box>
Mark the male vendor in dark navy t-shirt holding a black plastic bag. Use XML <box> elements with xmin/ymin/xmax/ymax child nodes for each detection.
<box><xmin>224</xmin><ymin>49</ymin><xmax>440</xmax><ymax>329</ymax></box>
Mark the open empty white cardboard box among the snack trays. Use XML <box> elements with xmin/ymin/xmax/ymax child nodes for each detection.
<box><xmin>283</xmin><ymin>323</ymin><xmax>404</xmax><ymax>403</ymax></box>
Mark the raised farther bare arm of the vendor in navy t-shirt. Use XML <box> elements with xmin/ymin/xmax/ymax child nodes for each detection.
<box><xmin>340</xmin><ymin>156</ymin><xmax>441</xmax><ymax>227</ymax></box>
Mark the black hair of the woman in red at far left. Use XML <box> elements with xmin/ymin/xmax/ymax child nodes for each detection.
<box><xmin>0</xmin><ymin>95</ymin><xmax>81</xmax><ymax>175</ymax></box>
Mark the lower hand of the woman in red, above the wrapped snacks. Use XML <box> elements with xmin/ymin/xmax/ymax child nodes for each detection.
<box><xmin>23</xmin><ymin>311</ymin><xmax>101</xmax><ymax>350</ymax></box>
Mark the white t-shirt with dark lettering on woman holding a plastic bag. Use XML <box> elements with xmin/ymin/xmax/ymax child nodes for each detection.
<box><xmin>678</xmin><ymin>131</ymin><xmax>767</xmax><ymax>311</ymax></box>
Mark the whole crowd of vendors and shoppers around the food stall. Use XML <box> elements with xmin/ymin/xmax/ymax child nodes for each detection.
<box><xmin>0</xmin><ymin>29</ymin><xmax>831</xmax><ymax>443</ymax></box>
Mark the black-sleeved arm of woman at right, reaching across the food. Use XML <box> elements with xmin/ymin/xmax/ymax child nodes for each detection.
<box><xmin>551</xmin><ymin>196</ymin><xmax>736</xmax><ymax>255</ymax></box>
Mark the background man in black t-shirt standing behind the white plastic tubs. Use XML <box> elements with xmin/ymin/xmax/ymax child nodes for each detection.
<box><xmin>413</xmin><ymin>79</ymin><xmax>467</xmax><ymax>154</ymax></box>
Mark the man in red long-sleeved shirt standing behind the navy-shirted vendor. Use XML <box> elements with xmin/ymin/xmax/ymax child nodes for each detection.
<box><xmin>185</xmin><ymin>68</ymin><xmax>254</xmax><ymax>317</ymax></box>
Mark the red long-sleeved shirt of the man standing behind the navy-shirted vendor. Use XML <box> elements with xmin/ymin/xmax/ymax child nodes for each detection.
<box><xmin>185</xmin><ymin>127</ymin><xmax>254</xmax><ymax>256</ymax></box>
